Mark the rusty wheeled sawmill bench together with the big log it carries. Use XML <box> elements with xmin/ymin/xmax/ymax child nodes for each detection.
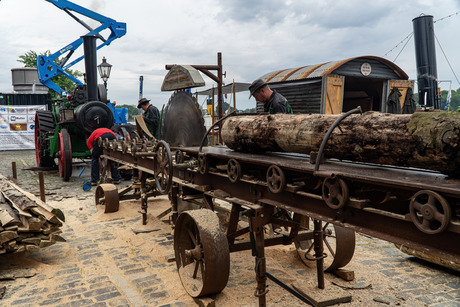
<box><xmin>91</xmin><ymin>59</ymin><xmax>460</xmax><ymax>306</ymax></box>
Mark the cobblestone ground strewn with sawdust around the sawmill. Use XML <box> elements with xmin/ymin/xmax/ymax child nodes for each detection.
<box><xmin>0</xmin><ymin>151</ymin><xmax>460</xmax><ymax>307</ymax></box>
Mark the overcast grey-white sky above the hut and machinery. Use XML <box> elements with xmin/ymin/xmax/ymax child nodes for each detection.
<box><xmin>0</xmin><ymin>0</ymin><xmax>460</xmax><ymax>109</ymax></box>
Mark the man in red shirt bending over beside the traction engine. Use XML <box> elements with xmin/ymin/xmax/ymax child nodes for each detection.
<box><xmin>86</xmin><ymin>128</ymin><xmax>121</xmax><ymax>186</ymax></box>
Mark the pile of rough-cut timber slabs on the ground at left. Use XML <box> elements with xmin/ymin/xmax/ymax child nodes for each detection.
<box><xmin>0</xmin><ymin>176</ymin><xmax>65</xmax><ymax>254</ymax></box>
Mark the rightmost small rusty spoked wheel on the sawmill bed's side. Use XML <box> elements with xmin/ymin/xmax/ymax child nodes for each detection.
<box><xmin>409</xmin><ymin>190</ymin><xmax>451</xmax><ymax>234</ymax></box>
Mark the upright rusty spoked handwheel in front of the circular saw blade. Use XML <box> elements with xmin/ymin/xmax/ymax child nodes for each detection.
<box><xmin>154</xmin><ymin>141</ymin><xmax>173</xmax><ymax>194</ymax></box>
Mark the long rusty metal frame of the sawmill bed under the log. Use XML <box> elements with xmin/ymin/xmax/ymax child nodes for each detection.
<box><xmin>99</xmin><ymin>138</ymin><xmax>460</xmax><ymax>305</ymax></box>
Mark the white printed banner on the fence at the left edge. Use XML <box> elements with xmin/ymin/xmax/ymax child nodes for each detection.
<box><xmin>0</xmin><ymin>105</ymin><xmax>46</xmax><ymax>150</ymax></box>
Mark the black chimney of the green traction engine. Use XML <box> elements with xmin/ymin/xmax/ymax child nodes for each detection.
<box><xmin>82</xmin><ymin>35</ymin><xmax>99</xmax><ymax>101</ymax></box>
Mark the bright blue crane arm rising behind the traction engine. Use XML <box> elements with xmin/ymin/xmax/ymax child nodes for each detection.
<box><xmin>37</xmin><ymin>0</ymin><xmax>126</xmax><ymax>95</ymax></box>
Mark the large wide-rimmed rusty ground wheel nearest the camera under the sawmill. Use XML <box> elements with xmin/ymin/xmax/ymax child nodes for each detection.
<box><xmin>174</xmin><ymin>209</ymin><xmax>230</xmax><ymax>297</ymax></box>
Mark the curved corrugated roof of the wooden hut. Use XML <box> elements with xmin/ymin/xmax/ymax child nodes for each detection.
<box><xmin>260</xmin><ymin>55</ymin><xmax>409</xmax><ymax>83</ymax></box>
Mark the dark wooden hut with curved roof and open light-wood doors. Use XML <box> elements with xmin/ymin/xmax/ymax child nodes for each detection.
<box><xmin>257</xmin><ymin>56</ymin><xmax>414</xmax><ymax>114</ymax></box>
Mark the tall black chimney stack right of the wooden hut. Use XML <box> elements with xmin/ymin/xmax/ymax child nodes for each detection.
<box><xmin>412</xmin><ymin>15</ymin><xmax>441</xmax><ymax>109</ymax></box>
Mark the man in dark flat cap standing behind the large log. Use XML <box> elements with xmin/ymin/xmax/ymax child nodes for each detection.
<box><xmin>249</xmin><ymin>79</ymin><xmax>292</xmax><ymax>114</ymax></box>
